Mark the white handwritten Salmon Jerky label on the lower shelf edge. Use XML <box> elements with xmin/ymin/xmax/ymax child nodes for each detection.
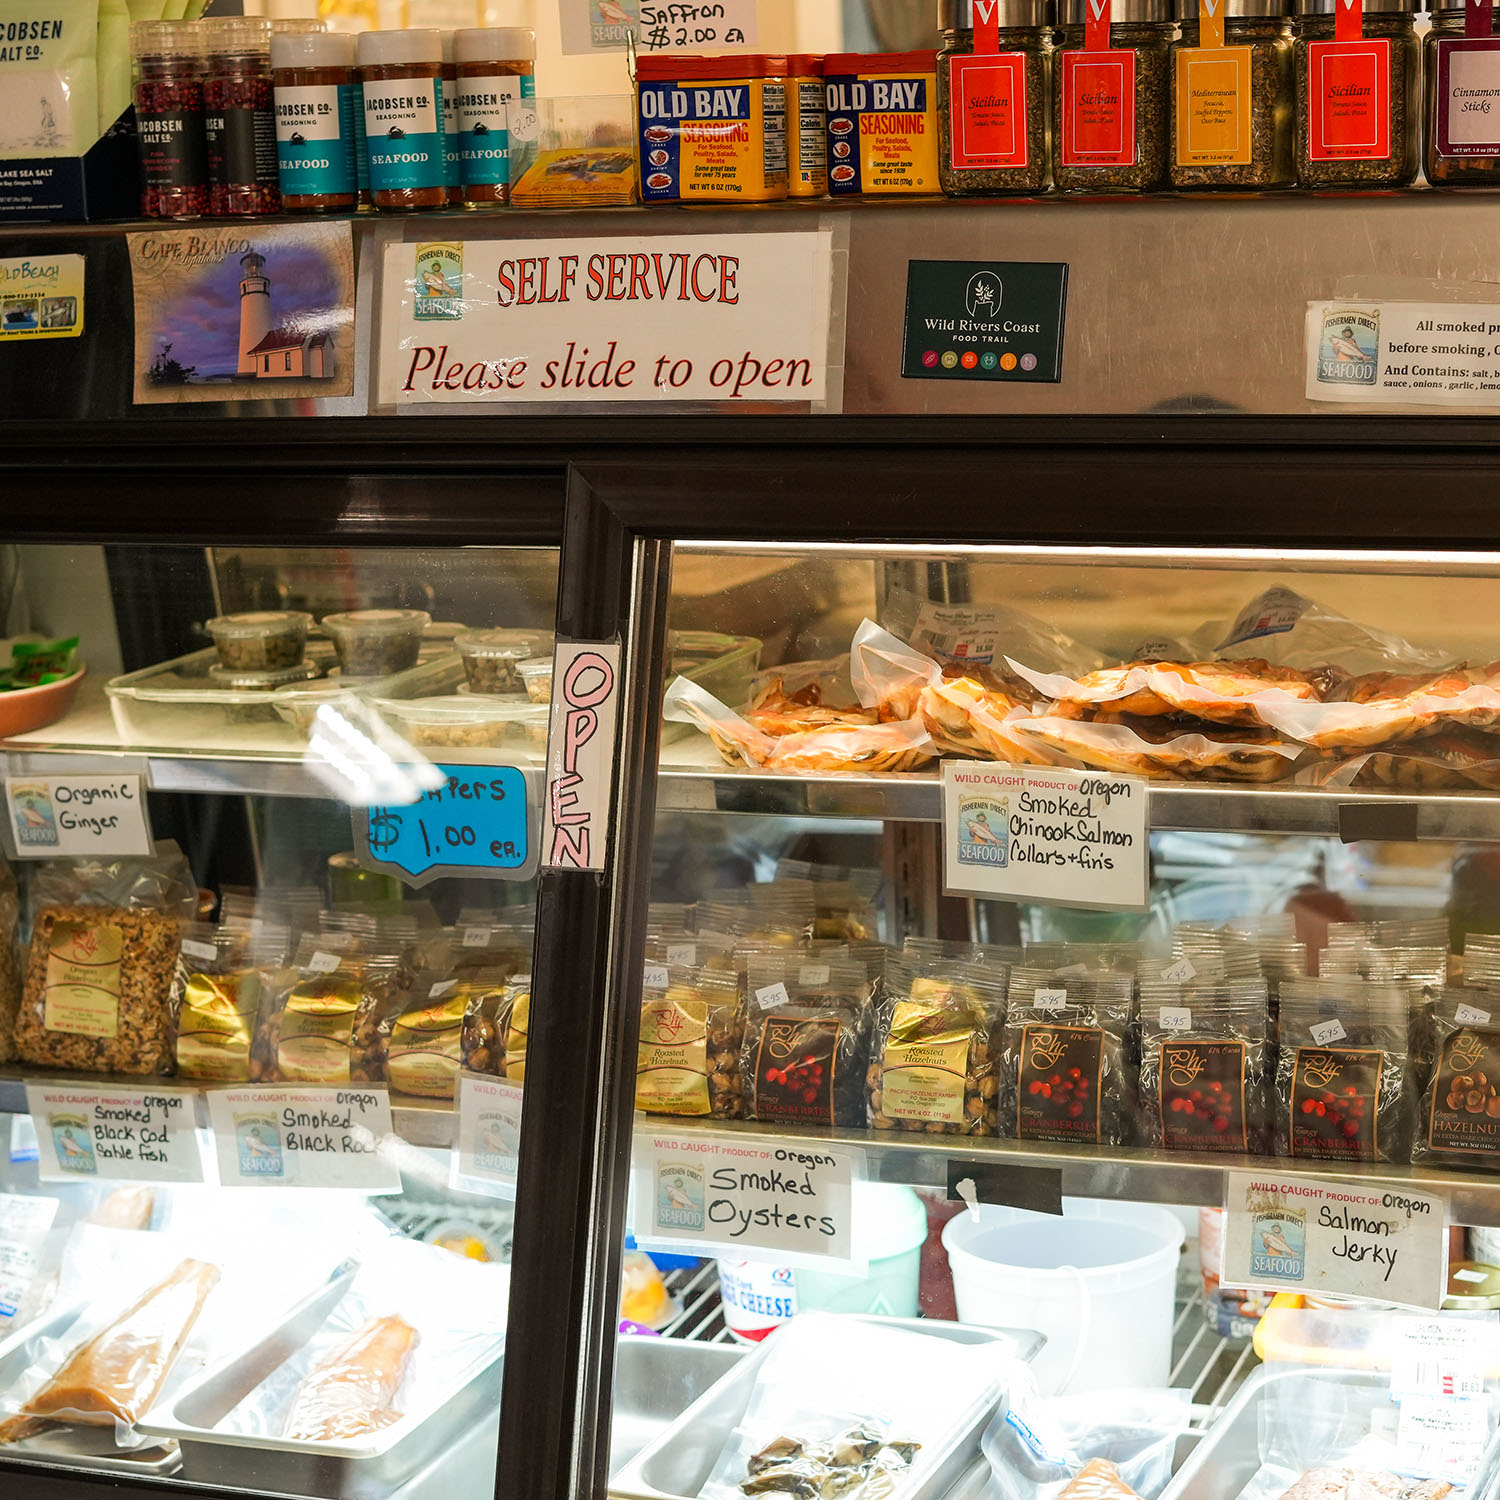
<box><xmin>1221</xmin><ymin>1170</ymin><xmax>1448</xmax><ymax>1308</ymax></box>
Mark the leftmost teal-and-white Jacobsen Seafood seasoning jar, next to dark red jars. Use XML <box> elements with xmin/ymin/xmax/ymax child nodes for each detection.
<box><xmin>272</xmin><ymin>32</ymin><xmax>357</xmax><ymax>213</ymax></box>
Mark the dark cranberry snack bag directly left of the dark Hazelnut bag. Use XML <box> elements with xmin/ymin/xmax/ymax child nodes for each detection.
<box><xmin>1277</xmin><ymin>977</ymin><xmax>1412</xmax><ymax>1161</ymax></box>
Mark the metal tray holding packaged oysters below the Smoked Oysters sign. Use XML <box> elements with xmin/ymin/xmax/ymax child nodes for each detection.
<box><xmin>609</xmin><ymin>1317</ymin><xmax>1046</xmax><ymax>1500</ymax></box>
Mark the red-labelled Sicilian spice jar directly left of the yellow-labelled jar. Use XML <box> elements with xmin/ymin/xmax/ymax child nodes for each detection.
<box><xmin>1052</xmin><ymin>0</ymin><xmax>1178</xmax><ymax>192</ymax></box>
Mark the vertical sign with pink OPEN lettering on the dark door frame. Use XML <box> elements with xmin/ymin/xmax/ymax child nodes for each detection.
<box><xmin>542</xmin><ymin>641</ymin><xmax>620</xmax><ymax>870</ymax></box>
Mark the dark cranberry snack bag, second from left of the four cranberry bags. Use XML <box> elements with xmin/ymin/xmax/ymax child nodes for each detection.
<box><xmin>1001</xmin><ymin>954</ymin><xmax>1136</xmax><ymax>1146</ymax></box>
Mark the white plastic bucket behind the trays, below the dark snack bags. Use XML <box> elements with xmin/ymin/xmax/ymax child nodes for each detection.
<box><xmin>942</xmin><ymin>1199</ymin><xmax>1185</xmax><ymax>1395</ymax></box>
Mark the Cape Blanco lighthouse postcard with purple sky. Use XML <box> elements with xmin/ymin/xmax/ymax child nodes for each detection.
<box><xmin>129</xmin><ymin>224</ymin><xmax>354</xmax><ymax>404</ymax></box>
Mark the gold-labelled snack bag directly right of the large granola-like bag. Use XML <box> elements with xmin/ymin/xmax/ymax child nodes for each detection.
<box><xmin>173</xmin><ymin>923</ymin><xmax>287</xmax><ymax>1083</ymax></box>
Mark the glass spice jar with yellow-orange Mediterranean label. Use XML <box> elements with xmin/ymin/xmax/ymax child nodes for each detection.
<box><xmin>1172</xmin><ymin>0</ymin><xmax>1296</xmax><ymax>189</ymax></box>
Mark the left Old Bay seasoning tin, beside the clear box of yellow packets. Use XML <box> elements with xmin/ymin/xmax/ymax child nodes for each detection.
<box><xmin>636</xmin><ymin>54</ymin><xmax>786</xmax><ymax>203</ymax></box>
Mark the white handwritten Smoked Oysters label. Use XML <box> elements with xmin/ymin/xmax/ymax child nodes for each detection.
<box><xmin>635</xmin><ymin>1133</ymin><xmax>864</xmax><ymax>1266</ymax></box>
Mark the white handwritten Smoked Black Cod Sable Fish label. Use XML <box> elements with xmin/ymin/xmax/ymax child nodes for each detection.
<box><xmin>26</xmin><ymin>1083</ymin><xmax>204</xmax><ymax>1182</ymax></box>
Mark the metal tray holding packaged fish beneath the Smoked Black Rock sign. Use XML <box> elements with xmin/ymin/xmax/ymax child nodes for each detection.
<box><xmin>141</xmin><ymin>1269</ymin><xmax>504</xmax><ymax>1500</ymax></box>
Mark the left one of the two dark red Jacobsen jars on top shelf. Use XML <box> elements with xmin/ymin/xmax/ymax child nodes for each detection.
<box><xmin>131</xmin><ymin>21</ymin><xmax>209</xmax><ymax>219</ymax></box>
